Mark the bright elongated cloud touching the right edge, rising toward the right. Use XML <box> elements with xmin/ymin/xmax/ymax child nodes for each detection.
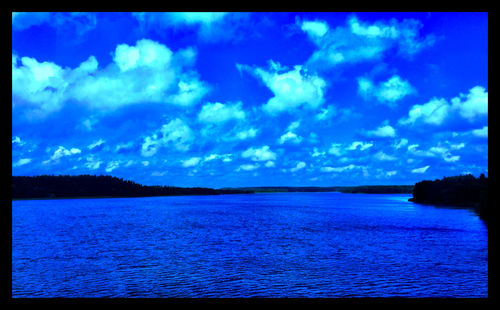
<box><xmin>399</xmin><ymin>86</ymin><xmax>488</xmax><ymax>126</ymax></box>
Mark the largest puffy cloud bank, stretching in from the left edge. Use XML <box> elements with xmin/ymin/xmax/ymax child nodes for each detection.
<box><xmin>12</xmin><ymin>39</ymin><xmax>210</xmax><ymax>118</ymax></box>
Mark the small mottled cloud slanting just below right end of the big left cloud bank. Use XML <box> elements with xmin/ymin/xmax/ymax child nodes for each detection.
<box><xmin>141</xmin><ymin>118</ymin><xmax>194</xmax><ymax>157</ymax></box>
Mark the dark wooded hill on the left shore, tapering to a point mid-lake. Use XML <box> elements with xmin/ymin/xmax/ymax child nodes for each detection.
<box><xmin>12</xmin><ymin>175</ymin><xmax>253</xmax><ymax>199</ymax></box>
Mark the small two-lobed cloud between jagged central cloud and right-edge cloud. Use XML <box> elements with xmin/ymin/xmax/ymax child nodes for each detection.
<box><xmin>358</xmin><ymin>75</ymin><xmax>416</xmax><ymax>107</ymax></box>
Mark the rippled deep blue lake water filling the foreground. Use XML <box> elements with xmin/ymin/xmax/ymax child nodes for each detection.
<box><xmin>12</xmin><ymin>193</ymin><xmax>488</xmax><ymax>297</ymax></box>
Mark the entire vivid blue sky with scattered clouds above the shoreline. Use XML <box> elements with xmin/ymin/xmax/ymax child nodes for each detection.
<box><xmin>12</xmin><ymin>12</ymin><xmax>488</xmax><ymax>188</ymax></box>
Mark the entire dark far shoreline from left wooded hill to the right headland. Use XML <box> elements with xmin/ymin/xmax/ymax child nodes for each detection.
<box><xmin>12</xmin><ymin>175</ymin><xmax>413</xmax><ymax>199</ymax></box>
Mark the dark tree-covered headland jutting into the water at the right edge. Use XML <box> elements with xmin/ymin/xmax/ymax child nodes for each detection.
<box><xmin>409</xmin><ymin>174</ymin><xmax>488</xmax><ymax>221</ymax></box>
